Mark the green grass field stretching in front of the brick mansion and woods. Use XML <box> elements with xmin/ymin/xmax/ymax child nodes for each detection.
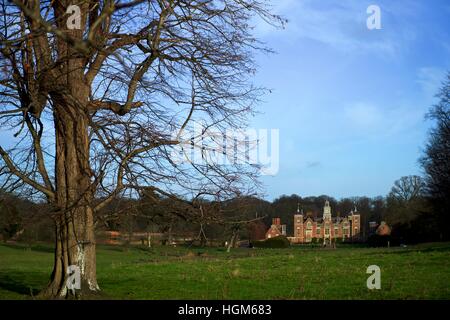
<box><xmin>0</xmin><ymin>243</ymin><xmax>450</xmax><ymax>299</ymax></box>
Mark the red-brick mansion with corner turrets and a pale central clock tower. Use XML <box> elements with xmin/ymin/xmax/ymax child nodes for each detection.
<box><xmin>266</xmin><ymin>201</ymin><xmax>361</xmax><ymax>244</ymax></box>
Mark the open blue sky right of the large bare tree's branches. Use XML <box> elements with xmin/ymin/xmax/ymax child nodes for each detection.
<box><xmin>252</xmin><ymin>0</ymin><xmax>450</xmax><ymax>199</ymax></box>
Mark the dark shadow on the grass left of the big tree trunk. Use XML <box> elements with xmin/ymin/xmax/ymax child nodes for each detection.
<box><xmin>0</xmin><ymin>271</ymin><xmax>48</xmax><ymax>299</ymax></box>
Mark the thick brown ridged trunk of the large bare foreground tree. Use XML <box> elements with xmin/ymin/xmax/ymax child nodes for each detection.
<box><xmin>35</xmin><ymin>4</ymin><xmax>99</xmax><ymax>298</ymax></box>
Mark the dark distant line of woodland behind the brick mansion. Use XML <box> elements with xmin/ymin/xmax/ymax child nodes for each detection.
<box><xmin>0</xmin><ymin>176</ymin><xmax>445</xmax><ymax>245</ymax></box>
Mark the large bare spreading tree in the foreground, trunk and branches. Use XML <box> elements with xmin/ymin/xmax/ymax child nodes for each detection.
<box><xmin>0</xmin><ymin>0</ymin><xmax>283</xmax><ymax>297</ymax></box>
